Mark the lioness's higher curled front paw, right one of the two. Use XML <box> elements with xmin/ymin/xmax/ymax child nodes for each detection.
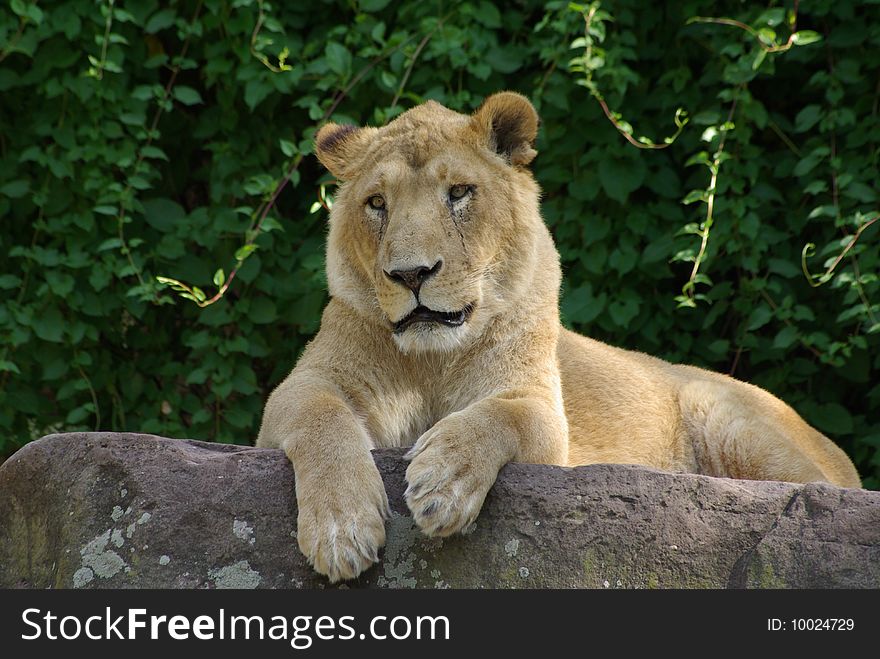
<box><xmin>404</xmin><ymin>423</ymin><xmax>495</xmax><ymax>537</ymax></box>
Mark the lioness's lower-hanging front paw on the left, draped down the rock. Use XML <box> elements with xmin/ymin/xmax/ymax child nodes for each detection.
<box><xmin>297</xmin><ymin>472</ymin><xmax>389</xmax><ymax>583</ymax></box>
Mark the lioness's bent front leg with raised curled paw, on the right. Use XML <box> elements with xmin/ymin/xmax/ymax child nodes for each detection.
<box><xmin>405</xmin><ymin>396</ymin><xmax>568</xmax><ymax>536</ymax></box>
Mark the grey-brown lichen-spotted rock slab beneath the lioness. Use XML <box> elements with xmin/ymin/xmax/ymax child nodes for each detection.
<box><xmin>0</xmin><ymin>433</ymin><xmax>880</xmax><ymax>588</ymax></box>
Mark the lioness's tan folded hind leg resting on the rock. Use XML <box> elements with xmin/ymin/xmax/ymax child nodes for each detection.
<box><xmin>679</xmin><ymin>380</ymin><xmax>830</xmax><ymax>483</ymax></box>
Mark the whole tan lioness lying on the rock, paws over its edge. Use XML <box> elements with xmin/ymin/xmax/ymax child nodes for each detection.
<box><xmin>257</xmin><ymin>92</ymin><xmax>860</xmax><ymax>582</ymax></box>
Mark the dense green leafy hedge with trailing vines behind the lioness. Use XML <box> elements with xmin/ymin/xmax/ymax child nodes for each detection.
<box><xmin>0</xmin><ymin>0</ymin><xmax>880</xmax><ymax>488</ymax></box>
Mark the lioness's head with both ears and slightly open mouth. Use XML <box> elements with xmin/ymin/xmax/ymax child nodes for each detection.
<box><xmin>316</xmin><ymin>93</ymin><xmax>537</xmax><ymax>353</ymax></box>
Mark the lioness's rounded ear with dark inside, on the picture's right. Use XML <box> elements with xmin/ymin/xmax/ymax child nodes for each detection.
<box><xmin>473</xmin><ymin>92</ymin><xmax>538</xmax><ymax>166</ymax></box>
